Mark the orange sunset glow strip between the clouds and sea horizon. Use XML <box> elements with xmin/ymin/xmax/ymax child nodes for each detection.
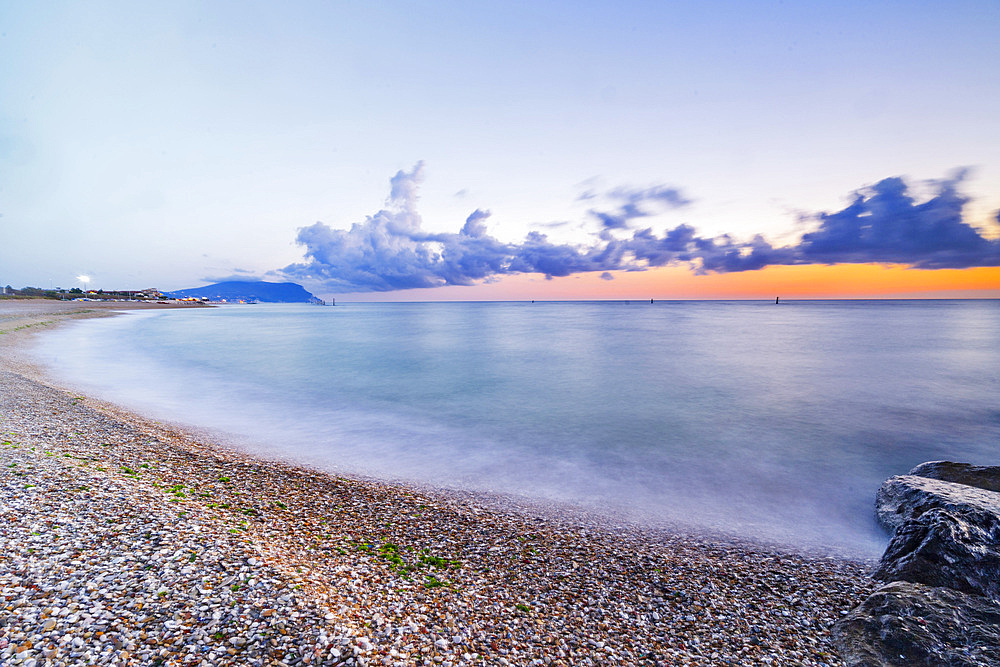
<box><xmin>334</xmin><ymin>264</ymin><xmax>1000</xmax><ymax>301</ymax></box>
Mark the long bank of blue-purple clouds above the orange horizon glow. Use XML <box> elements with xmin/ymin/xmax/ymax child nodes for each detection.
<box><xmin>277</xmin><ymin>162</ymin><xmax>1000</xmax><ymax>292</ymax></box>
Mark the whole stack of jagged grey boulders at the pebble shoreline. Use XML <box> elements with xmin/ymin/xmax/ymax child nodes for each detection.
<box><xmin>833</xmin><ymin>461</ymin><xmax>1000</xmax><ymax>667</ymax></box>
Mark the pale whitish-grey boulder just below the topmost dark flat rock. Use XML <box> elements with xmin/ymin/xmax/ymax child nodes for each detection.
<box><xmin>875</xmin><ymin>475</ymin><xmax>1000</xmax><ymax>532</ymax></box>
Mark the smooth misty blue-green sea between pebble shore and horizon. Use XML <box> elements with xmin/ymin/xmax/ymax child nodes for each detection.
<box><xmin>31</xmin><ymin>301</ymin><xmax>1000</xmax><ymax>556</ymax></box>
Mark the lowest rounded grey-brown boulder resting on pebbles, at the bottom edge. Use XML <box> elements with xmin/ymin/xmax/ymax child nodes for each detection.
<box><xmin>832</xmin><ymin>582</ymin><xmax>1000</xmax><ymax>667</ymax></box>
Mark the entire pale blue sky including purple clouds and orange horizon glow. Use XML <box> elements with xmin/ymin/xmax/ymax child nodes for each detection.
<box><xmin>0</xmin><ymin>0</ymin><xmax>1000</xmax><ymax>301</ymax></box>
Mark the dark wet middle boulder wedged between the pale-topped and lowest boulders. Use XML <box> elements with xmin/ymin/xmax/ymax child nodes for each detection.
<box><xmin>872</xmin><ymin>507</ymin><xmax>1000</xmax><ymax>601</ymax></box>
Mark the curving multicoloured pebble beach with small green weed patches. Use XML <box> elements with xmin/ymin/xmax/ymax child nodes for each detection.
<box><xmin>0</xmin><ymin>301</ymin><xmax>875</xmax><ymax>666</ymax></box>
